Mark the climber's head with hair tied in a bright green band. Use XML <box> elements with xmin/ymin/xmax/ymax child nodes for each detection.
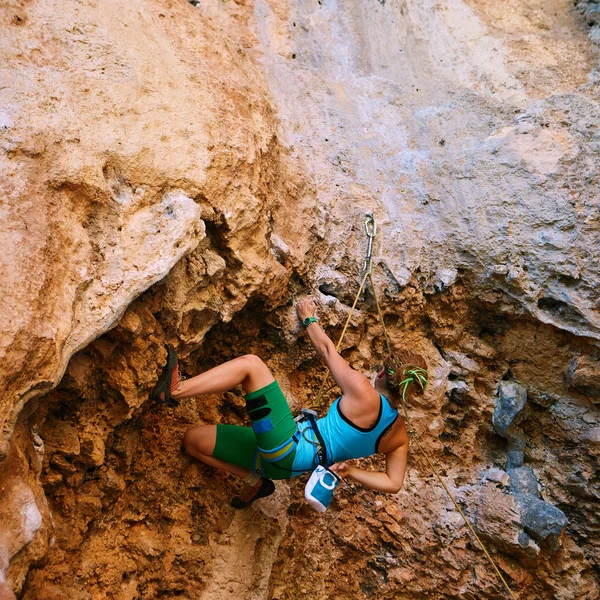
<box><xmin>375</xmin><ymin>351</ymin><xmax>429</xmax><ymax>406</ymax></box>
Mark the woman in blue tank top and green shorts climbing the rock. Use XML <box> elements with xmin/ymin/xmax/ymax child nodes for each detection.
<box><xmin>152</xmin><ymin>299</ymin><xmax>427</xmax><ymax>508</ymax></box>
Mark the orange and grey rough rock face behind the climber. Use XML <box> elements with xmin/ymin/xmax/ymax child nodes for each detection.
<box><xmin>0</xmin><ymin>0</ymin><xmax>600</xmax><ymax>600</ymax></box>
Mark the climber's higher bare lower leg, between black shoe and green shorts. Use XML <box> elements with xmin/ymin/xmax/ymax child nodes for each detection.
<box><xmin>171</xmin><ymin>354</ymin><xmax>274</xmax><ymax>400</ymax></box>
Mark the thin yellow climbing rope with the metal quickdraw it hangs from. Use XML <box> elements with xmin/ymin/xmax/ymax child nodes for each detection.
<box><xmin>315</xmin><ymin>214</ymin><xmax>516</xmax><ymax>600</ymax></box>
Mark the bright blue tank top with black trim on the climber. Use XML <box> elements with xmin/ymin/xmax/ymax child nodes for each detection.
<box><xmin>293</xmin><ymin>394</ymin><xmax>398</xmax><ymax>471</ymax></box>
